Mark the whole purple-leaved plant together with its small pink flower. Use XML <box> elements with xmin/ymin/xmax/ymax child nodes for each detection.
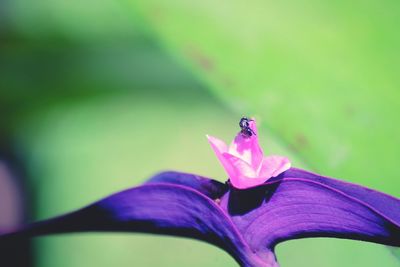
<box><xmin>0</xmin><ymin>121</ymin><xmax>400</xmax><ymax>267</ymax></box>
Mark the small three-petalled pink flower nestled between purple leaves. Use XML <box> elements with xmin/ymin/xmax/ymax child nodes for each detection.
<box><xmin>207</xmin><ymin>120</ymin><xmax>291</xmax><ymax>189</ymax></box>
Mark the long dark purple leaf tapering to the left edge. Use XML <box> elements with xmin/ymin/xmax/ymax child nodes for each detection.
<box><xmin>0</xmin><ymin>177</ymin><xmax>273</xmax><ymax>266</ymax></box>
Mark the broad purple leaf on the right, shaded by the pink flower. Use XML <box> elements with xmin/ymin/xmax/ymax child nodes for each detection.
<box><xmin>221</xmin><ymin>169</ymin><xmax>400</xmax><ymax>251</ymax></box>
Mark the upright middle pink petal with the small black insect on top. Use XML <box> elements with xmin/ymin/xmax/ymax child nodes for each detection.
<box><xmin>229</xmin><ymin>121</ymin><xmax>264</xmax><ymax>169</ymax></box>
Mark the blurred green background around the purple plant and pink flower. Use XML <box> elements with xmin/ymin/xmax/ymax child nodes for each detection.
<box><xmin>0</xmin><ymin>0</ymin><xmax>400</xmax><ymax>267</ymax></box>
